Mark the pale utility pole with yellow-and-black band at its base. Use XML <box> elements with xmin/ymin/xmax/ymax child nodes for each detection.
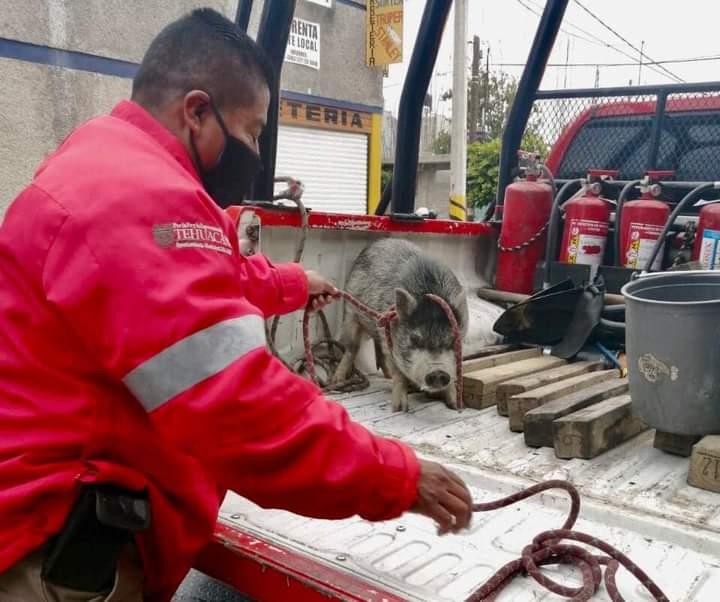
<box><xmin>448</xmin><ymin>0</ymin><xmax>466</xmax><ymax>221</ymax></box>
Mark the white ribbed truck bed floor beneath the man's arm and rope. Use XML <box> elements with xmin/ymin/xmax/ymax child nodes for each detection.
<box><xmin>221</xmin><ymin>379</ymin><xmax>720</xmax><ymax>602</ymax></box>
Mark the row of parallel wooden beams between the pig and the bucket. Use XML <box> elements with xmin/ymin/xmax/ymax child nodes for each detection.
<box><xmin>463</xmin><ymin>349</ymin><xmax>648</xmax><ymax>459</ymax></box>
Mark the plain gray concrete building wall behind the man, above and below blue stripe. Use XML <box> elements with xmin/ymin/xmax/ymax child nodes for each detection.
<box><xmin>0</xmin><ymin>0</ymin><xmax>382</xmax><ymax>214</ymax></box>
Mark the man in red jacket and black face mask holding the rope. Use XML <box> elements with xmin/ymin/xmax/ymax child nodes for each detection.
<box><xmin>0</xmin><ymin>9</ymin><xmax>471</xmax><ymax>602</ymax></box>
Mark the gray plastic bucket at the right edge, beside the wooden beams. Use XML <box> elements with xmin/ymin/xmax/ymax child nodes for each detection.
<box><xmin>621</xmin><ymin>271</ymin><xmax>720</xmax><ymax>435</ymax></box>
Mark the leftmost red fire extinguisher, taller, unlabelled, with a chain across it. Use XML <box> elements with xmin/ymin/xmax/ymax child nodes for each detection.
<box><xmin>495</xmin><ymin>156</ymin><xmax>554</xmax><ymax>294</ymax></box>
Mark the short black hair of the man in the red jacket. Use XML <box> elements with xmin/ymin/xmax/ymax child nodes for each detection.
<box><xmin>132</xmin><ymin>8</ymin><xmax>275</xmax><ymax>108</ymax></box>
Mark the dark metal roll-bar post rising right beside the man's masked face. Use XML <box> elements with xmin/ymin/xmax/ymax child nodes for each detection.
<box><xmin>251</xmin><ymin>0</ymin><xmax>296</xmax><ymax>201</ymax></box>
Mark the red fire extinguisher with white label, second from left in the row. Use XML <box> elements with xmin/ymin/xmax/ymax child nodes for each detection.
<box><xmin>559</xmin><ymin>169</ymin><xmax>618</xmax><ymax>271</ymax></box>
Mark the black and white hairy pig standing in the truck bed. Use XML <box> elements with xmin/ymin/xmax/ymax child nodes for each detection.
<box><xmin>332</xmin><ymin>238</ymin><xmax>468</xmax><ymax>412</ymax></box>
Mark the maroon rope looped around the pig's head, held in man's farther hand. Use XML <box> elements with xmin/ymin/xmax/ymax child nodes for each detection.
<box><xmin>302</xmin><ymin>291</ymin><xmax>464</xmax><ymax>410</ymax></box>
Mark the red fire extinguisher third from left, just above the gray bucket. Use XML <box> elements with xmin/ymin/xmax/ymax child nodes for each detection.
<box><xmin>616</xmin><ymin>171</ymin><xmax>674</xmax><ymax>270</ymax></box>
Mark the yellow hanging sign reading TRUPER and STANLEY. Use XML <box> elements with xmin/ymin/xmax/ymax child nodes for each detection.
<box><xmin>366</xmin><ymin>0</ymin><xmax>404</xmax><ymax>67</ymax></box>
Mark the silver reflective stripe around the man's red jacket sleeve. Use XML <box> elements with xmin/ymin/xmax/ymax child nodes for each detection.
<box><xmin>123</xmin><ymin>315</ymin><xmax>265</xmax><ymax>412</ymax></box>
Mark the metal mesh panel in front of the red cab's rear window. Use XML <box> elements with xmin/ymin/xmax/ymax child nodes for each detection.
<box><xmin>523</xmin><ymin>84</ymin><xmax>720</xmax><ymax>190</ymax></box>
